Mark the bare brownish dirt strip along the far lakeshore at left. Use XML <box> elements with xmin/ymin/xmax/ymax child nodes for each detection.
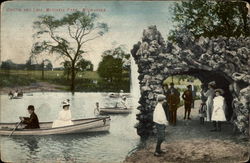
<box><xmin>0</xmin><ymin>82</ymin><xmax>65</xmax><ymax>94</ymax></box>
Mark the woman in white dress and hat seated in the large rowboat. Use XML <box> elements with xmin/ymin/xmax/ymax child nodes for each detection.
<box><xmin>52</xmin><ymin>100</ymin><xmax>73</xmax><ymax>128</ymax></box>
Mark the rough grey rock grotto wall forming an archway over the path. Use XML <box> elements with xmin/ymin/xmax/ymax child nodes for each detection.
<box><xmin>131</xmin><ymin>26</ymin><xmax>250</xmax><ymax>137</ymax></box>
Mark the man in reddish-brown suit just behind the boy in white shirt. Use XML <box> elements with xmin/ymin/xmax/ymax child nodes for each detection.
<box><xmin>167</xmin><ymin>83</ymin><xmax>180</xmax><ymax>125</ymax></box>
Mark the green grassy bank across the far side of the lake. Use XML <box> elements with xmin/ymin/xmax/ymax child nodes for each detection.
<box><xmin>0</xmin><ymin>70</ymin><xmax>130</xmax><ymax>92</ymax></box>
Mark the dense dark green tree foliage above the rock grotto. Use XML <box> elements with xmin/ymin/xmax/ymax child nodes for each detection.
<box><xmin>169</xmin><ymin>0</ymin><xmax>250</xmax><ymax>41</ymax></box>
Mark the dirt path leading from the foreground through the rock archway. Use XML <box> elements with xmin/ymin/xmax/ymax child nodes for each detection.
<box><xmin>124</xmin><ymin>101</ymin><xmax>250</xmax><ymax>163</ymax></box>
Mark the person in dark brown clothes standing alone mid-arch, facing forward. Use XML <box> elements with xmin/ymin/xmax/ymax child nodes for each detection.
<box><xmin>182</xmin><ymin>85</ymin><xmax>193</xmax><ymax>120</ymax></box>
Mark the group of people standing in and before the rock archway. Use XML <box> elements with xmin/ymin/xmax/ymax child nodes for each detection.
<box><xmin>153</xmin><ymin>81</ymin><xmax>229</xmax><ymax>156</ymax></box>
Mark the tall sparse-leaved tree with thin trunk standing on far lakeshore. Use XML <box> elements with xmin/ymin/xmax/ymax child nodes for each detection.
<box><xmin>32</xmin><ymin>11</ymin><xmax>108</xmax><ymax>92</ymax></box>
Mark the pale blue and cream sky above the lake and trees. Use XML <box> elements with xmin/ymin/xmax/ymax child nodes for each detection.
<box><xmin>1</xmin><ymin>1</ymin><xmax>175</xmax><ymax>69</ymax></box>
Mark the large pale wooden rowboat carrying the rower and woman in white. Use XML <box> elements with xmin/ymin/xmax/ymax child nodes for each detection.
<box><xmin>0</xmin><ymin>116</ymin><xmax>110</xmax><ymax>135</ymax></box>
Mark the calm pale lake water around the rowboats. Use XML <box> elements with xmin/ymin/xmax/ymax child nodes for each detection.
<box><xmin>0</xmin><ymin>92</ymin><xmax>139</xmax><ymax>163</ymax></box>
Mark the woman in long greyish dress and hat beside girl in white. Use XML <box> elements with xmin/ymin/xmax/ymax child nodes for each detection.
<box><xmin>204</xmin><ymin>82</ymin><xmax>215</xmax><ymax>122</ymax></box>
